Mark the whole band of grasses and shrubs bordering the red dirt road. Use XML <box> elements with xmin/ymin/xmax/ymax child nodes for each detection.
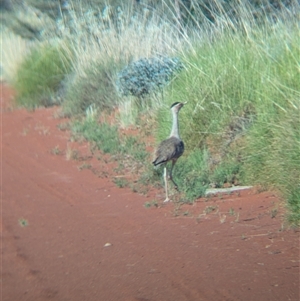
<box><xmin>1</xmin><ymin>0</ymin><xmax>300</xmax><ymax>225</ymax></box>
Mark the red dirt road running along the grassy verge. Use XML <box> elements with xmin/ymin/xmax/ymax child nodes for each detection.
<box><xmin>1</xmin><ymin>82</ymin><xmax>299</xmax><ymax>301</ymax></box>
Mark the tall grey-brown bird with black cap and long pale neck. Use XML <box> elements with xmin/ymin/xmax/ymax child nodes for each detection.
<box><xmin>152</xmin><ymin>102</ymin><xmax>186</xmax><ymax>203</ymax></box>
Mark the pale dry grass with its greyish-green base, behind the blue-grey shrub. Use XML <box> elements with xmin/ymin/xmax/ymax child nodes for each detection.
<box><xmin>44</xmin><ymin>4</ymin><xmax>186</xmax><ymax>119</ymax></box>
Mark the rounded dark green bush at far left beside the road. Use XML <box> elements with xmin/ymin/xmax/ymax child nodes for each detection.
<box><xmin>13</xmin><ymin>43</ymin><xmax>72</xmax><ymax>108</ymax></box>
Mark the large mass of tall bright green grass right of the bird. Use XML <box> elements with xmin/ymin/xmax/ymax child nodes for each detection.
<box><xmin>157</xmin><ymin>5</ymin><xmax>300</xmax><ymax>223</ymax></box>
